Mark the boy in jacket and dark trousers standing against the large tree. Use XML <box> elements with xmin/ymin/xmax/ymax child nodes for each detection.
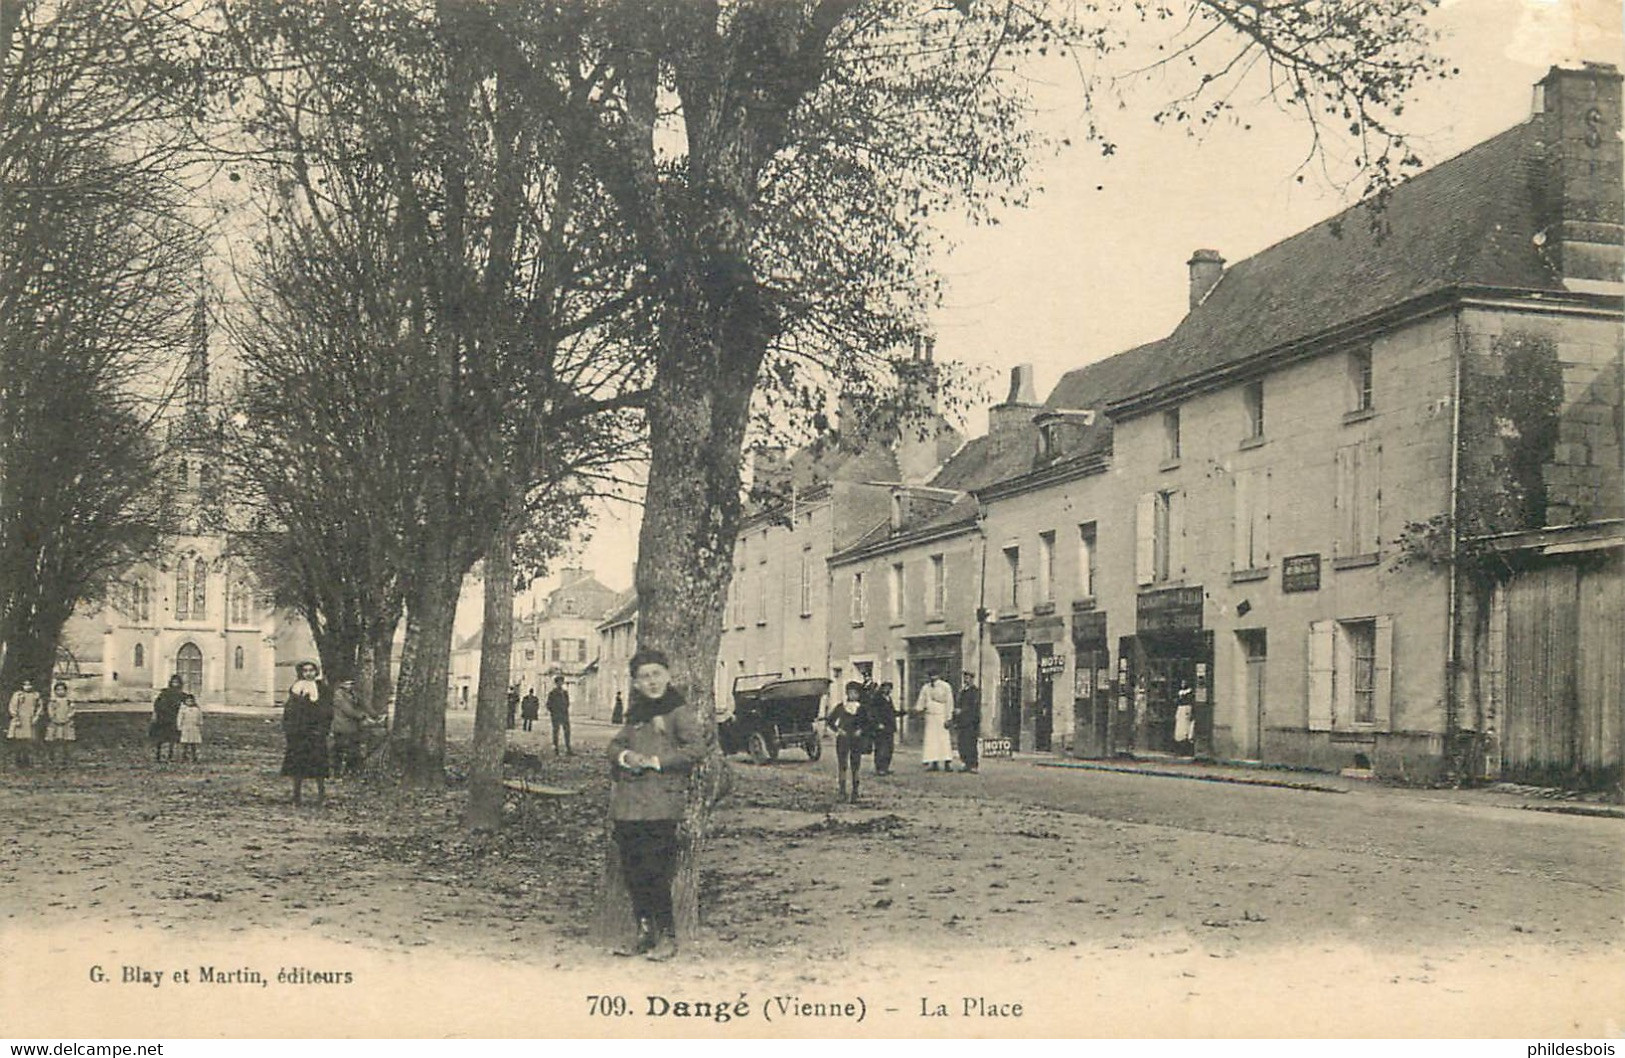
<box><xmin>601</xmin><ymin>648</ymin><xmax>705</xmax><ymax>960</ymax></box>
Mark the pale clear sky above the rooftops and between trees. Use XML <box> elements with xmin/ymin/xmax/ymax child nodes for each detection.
<box><xmin>490</xmin><ymin>0</ymin><xmax>1622</xmax><ymax>604</ymax></box>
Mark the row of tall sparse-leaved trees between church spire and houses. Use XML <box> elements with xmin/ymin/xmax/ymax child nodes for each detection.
<box><xmin>3</xmin><ymin>0</ymin><xmax>1437</xmax><ymax>920</ymax></box>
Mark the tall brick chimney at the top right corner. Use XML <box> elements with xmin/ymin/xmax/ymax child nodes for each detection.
<box><xmin>1534</xmin><ymin>62</ymin><xmax>1625</xmax><ymax>284</ymax></box>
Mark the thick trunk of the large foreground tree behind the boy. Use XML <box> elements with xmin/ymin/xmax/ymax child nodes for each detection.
<box><xmin>598</xmin><ymin>282</ymin><xmax>765</xmax><ymax>946</ymax></box>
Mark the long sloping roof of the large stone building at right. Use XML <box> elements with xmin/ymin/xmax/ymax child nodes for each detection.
<box><xmin>1045</xmin><ymin>122</ymin><xmax>1563</xmax><ymax>408</ymax></box>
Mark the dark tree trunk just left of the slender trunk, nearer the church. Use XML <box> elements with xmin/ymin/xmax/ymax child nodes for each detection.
<box><xmin>381</xmin><ymin>564</ymin><xmax>463</xmax><ymax>787</ymax></box>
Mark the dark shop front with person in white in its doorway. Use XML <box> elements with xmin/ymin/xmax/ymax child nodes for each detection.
<box><xmin>1118</xmin><ymin>587</ymin><xmax>1214</xmax><ymax>756</ymax></box>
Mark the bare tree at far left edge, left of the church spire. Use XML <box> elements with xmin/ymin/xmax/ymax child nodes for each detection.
<box><xmin>0</xmin><ymin>0</ymin><xmax>209</xmax><ymax>687</ymax></box>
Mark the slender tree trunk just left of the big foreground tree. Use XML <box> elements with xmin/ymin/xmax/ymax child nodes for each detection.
<box><xmin>466</xmin><ymin>522</ymin><xmax>514</xmax><ymax>830</ymax></box>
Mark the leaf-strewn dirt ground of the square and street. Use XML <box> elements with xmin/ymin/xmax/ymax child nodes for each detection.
<box><xmin>0</xmin><ymin>713</ymin><xmax>1625</xmax><ymax>1037</ymax></box>
